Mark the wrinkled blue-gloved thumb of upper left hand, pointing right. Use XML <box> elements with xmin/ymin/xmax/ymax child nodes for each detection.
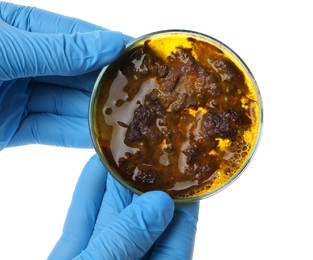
<box><xmin>0</xmin><ymin>20</ymin><xmax>125</xmax><ymax>81</ymax></box>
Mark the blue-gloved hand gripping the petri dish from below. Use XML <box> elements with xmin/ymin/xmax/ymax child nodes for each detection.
<box><xmin>49</xmin><ymin>156</ymin><xmax>199</xmax><ymax>260</ymax></box>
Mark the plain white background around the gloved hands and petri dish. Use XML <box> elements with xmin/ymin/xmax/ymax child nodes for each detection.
<box><xmin>0</xmin><ymin>0</ymin><xmax>313</xmax><ymax>260</ymax></box>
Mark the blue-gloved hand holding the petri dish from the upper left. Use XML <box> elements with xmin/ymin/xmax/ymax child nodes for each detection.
<box><xmin>0</xmin><ymin>2</ymin><xmax>130</xmax><ymax>150</ymax></box>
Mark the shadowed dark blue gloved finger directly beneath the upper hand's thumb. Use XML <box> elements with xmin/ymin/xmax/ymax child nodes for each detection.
<box><xmin>33</xmin><ymin>70</ymin><xmax>100</xmax><ymax>93</ymax></box>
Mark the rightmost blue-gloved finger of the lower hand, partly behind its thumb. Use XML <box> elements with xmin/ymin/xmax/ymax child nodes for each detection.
<box><xmin>149</xmin><ymin>202</ymin><xmax>199</xmax><ymax>260</ymax></box>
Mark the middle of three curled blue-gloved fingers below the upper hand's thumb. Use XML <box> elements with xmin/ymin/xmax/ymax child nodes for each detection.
<box><xmin>27</xmin><ymin>83</ymin><xmax>90</xmax><ymax>119</ymax></box>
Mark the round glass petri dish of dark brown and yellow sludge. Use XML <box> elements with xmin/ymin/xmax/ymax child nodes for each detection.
<box><xmin>89</xmin><ymin>30</ymin><xmax>263</xmax><ymax>202</ymax></box>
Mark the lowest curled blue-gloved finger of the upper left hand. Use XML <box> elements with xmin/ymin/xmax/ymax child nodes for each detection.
<box><xmin>7</xmin><ymin>113</ymin><xmax>93</xmax><ymax>148</ymax></box>
